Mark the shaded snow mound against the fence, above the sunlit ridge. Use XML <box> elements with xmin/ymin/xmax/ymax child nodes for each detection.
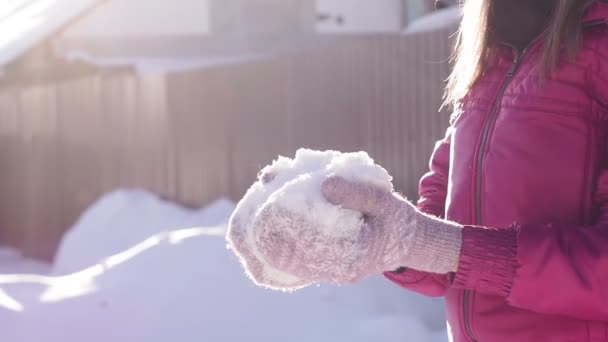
<box><xmin>54</xmin><ymin>190</ymin><xmax>234</xmax><ymax>273</ymax></box>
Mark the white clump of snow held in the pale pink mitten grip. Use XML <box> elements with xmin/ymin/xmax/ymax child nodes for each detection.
<box><xmin>227</xmin><ymin>149</ymin><xmax>392</xmax><ymax>290</ymax></box>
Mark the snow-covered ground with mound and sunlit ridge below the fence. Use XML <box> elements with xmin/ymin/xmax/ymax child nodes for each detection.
<box><xmin>0</xmin><ymin>191</ymin><xmax>447</xmax><ymax>342</ymax></box>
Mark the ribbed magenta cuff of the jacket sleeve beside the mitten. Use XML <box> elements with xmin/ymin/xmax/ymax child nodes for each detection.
<box><xmin>453</xmin><ymin>227</ymin><xmax>518</xmax><ymax>297</ymax></box>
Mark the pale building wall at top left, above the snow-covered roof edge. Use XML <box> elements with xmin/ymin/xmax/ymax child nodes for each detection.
<box><xmin>64</xmin><ymin>0</ymin><xmax>314</xmax><ymax>39</ymax></box>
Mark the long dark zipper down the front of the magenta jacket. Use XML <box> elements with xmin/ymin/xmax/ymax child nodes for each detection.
<box><xmin>463</xmin><ymin>48</ymin><xmax>528</xmax><ymax>342</ymax></box>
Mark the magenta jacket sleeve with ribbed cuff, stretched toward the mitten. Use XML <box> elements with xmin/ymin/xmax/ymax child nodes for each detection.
<box><xmin>453</xmin><ymin>219</ymin><xmax>608</xmax><ymax>321</ymax></box>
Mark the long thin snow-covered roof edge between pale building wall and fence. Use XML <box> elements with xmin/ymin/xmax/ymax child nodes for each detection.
<box><xmin>54</xmin><ymin>31</ymin><xmax>329</xmax><ymax>74</ymax></box>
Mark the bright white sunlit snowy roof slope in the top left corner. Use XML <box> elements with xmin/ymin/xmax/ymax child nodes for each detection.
<box><xmin>0</xmin><ymin>0</ymin><xmax>98</xmax><ymax>66</ymax></box>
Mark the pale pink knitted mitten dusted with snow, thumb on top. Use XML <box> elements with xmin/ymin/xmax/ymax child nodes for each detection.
<box><xmin>255</xmin><ymin>177</ymin><xmax>461</xmax><ymax>284</ymax></box>
